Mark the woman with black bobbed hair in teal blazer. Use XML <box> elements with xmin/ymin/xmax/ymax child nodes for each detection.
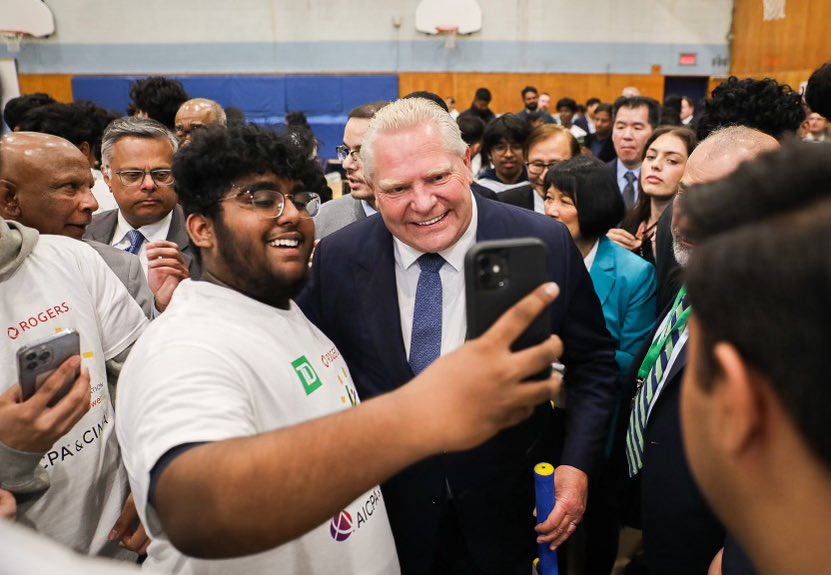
<box><xmin>544</xmin><ymin>156</ymin><xmax>658</xmax><ymax>573</ymax></box>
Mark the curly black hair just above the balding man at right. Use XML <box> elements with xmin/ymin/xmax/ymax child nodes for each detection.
<box><xmin>697</xmin><ymin>76</ymin><xmax>805</xmax><ymax>141</ymax></box>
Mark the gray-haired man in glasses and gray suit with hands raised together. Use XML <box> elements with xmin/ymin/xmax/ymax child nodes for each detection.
<box><xmin>84</xmin><ymin>117</ymin><xmax>200</xmax><ymax>287</ymax></box>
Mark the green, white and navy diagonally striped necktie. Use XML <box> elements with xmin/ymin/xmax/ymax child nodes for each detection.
<box><xmin>626</xmin><ymin>295</ymin><xmax>689</xmax><ymax>477</ymax></box>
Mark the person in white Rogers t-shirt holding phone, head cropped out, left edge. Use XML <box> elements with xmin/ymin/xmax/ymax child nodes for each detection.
<box><xmin>0</xmin><ymin>215</ymin><xmax>147</xmax><ymax>559</ymax></box>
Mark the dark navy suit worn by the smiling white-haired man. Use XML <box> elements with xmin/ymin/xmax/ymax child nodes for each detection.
<box><xmin>298</xmin><ymin>196</ymin><xmax>617</xmax><ymax>575</ymax></box>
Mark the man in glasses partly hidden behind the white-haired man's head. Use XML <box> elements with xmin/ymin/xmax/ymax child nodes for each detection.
<box><xmin>315</xmin><ymin>102</ymin><xmax>389</xmax><ymax>239</ymax></box>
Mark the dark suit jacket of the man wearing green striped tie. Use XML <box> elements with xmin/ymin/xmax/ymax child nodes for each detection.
<box><xmin>620</xmin><ymin>302</ymin><xmax>752</xmax><ymax>575</ymax></box>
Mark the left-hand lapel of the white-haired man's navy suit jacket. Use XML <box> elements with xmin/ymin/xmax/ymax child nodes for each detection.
<box><xmin>354</xmin><ymin>216</ymin><xmax>413</xmax><ymax>390</ymax></box>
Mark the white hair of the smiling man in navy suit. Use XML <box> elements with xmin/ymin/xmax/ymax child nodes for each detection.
<box><xmin>361</xmin><ymin>98</ymin><xmax>467</xmax><ymax>182</ymax></box>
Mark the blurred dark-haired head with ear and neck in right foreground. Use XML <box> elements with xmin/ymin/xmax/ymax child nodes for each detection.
<box><xmin>683</xmin><ymin>145</ymin><xmax>831</xmax><ymax>573</ymax></box>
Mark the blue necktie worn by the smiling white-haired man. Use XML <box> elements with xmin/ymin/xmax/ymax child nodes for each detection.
<box><xmin>410</xmin><ymin>254</ymin><xmax>444</xmax><ymax>375</ymax></box>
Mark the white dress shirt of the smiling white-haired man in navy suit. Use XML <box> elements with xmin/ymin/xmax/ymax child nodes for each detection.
<box><xmin>393</xmin><ymin>198</ymin><xmax>479</xmax><ymax>364</ymax></box>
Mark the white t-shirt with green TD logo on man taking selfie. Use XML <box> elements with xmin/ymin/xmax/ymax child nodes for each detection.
<box><xmin>117</xmin><ymin>280</ymin><xmax>400</xmax><ymax>575</ymax></box>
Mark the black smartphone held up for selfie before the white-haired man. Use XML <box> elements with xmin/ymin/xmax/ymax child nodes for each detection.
<box><xmin>465</xmin><ymin>238</ymin><xmax>551</xmax><ymax>379</ymax></box>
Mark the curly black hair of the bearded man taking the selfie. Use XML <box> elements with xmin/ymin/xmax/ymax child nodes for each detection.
<box><xmin>173</xmin><ymin>124</ymin><xmax>328</xmax><ymax>218</ymax></box>
